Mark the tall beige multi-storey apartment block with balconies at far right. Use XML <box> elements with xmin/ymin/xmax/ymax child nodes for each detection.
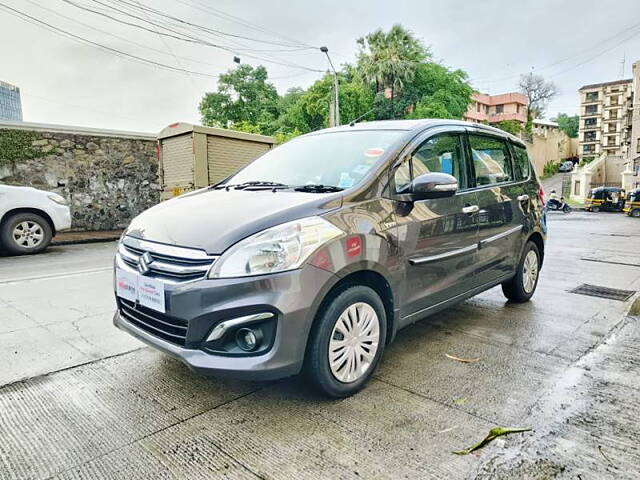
<box><xmin>578</xmin><ymin>79</ymin><xmax>633</xmax><ymax>160</ymax></box>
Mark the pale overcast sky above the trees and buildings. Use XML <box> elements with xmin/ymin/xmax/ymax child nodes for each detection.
<box><xmin>0</xmin><ymin>0</ymin><xmax>640</xmax><ymax>133</ymax></box>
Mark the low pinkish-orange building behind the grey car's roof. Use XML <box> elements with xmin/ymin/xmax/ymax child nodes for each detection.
<box><xmin>463</xmin><ymin>92</ymin><xmax>529</xmax><ymax>125</ymax></box>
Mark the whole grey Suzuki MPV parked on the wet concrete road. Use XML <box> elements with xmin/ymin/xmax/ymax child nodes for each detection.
<box><xmin>114</xmin><ymin>120</ymin><xmax>545</xmax><ymax>397</ymax></box>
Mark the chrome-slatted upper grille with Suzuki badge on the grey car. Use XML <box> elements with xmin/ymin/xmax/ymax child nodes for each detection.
<box><xmin>118</xmin><ymin>237</ymin><xmax>218</xmax><ymax>282</ymax></box>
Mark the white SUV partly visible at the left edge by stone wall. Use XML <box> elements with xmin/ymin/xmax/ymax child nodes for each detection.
<box><xmin>0</xmin><ymin>185</ymin><xmax>71</xmax><ymax>255</ymax></box>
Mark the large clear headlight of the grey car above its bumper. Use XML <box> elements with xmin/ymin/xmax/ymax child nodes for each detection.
<box><xmin>209</xmin><ymin>217</ymin><xmax>344</xmax><ymax>278</ymax></box>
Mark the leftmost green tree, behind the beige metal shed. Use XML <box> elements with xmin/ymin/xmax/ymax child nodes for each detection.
<box><xmin>199</xmin><ymin>65</ymin><xmax>279</xmax><ymax>133</ymax></box>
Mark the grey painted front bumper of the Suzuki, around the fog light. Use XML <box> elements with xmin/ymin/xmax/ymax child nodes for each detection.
<box><xmin>113</xmin><ymin>265</ymin><xmax>336</xmax><ymax>380</ymax></box>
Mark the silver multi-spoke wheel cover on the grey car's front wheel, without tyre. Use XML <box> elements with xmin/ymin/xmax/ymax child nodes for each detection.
<box><xmin>329</xmin><ymin>302</ymin><xmax>380</xmax><ymax>383</ymax></box>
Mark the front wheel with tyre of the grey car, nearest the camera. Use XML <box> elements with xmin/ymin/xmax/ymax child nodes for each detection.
<box><xmin>306</xmin><ymin>286</ymin><xmax>387</xmax><ymax>398</ymax></box>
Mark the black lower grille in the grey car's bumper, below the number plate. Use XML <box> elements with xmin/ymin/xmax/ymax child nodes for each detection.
<box><xmin>118</xmin><ymin>298</ymin><xmax>187</xmax><ymax>347</ymax></box>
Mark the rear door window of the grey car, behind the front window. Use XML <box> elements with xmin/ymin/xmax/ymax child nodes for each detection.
<box><xmin>469</xmin><ymin>135</ymin><xmax>513</xmax><ymax>187</ymax></box>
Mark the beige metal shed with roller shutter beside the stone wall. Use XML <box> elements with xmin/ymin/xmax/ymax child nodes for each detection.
<box><xmin>158</xmin><ymin>123</ymin><xmax>275</xmax><ymax>200</ymax></box>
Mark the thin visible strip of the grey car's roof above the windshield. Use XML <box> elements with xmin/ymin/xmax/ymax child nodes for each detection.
<box><xmin>307</xmin><ymin>118</ymin><xmax>525</xmax><ymax>146</ymax></box>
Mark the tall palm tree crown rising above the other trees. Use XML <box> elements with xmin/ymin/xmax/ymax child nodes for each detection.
<box><xmin>358</xmin><ymin>25</ymin><xmax>431</xmax><ymax>101</ymax></box>
